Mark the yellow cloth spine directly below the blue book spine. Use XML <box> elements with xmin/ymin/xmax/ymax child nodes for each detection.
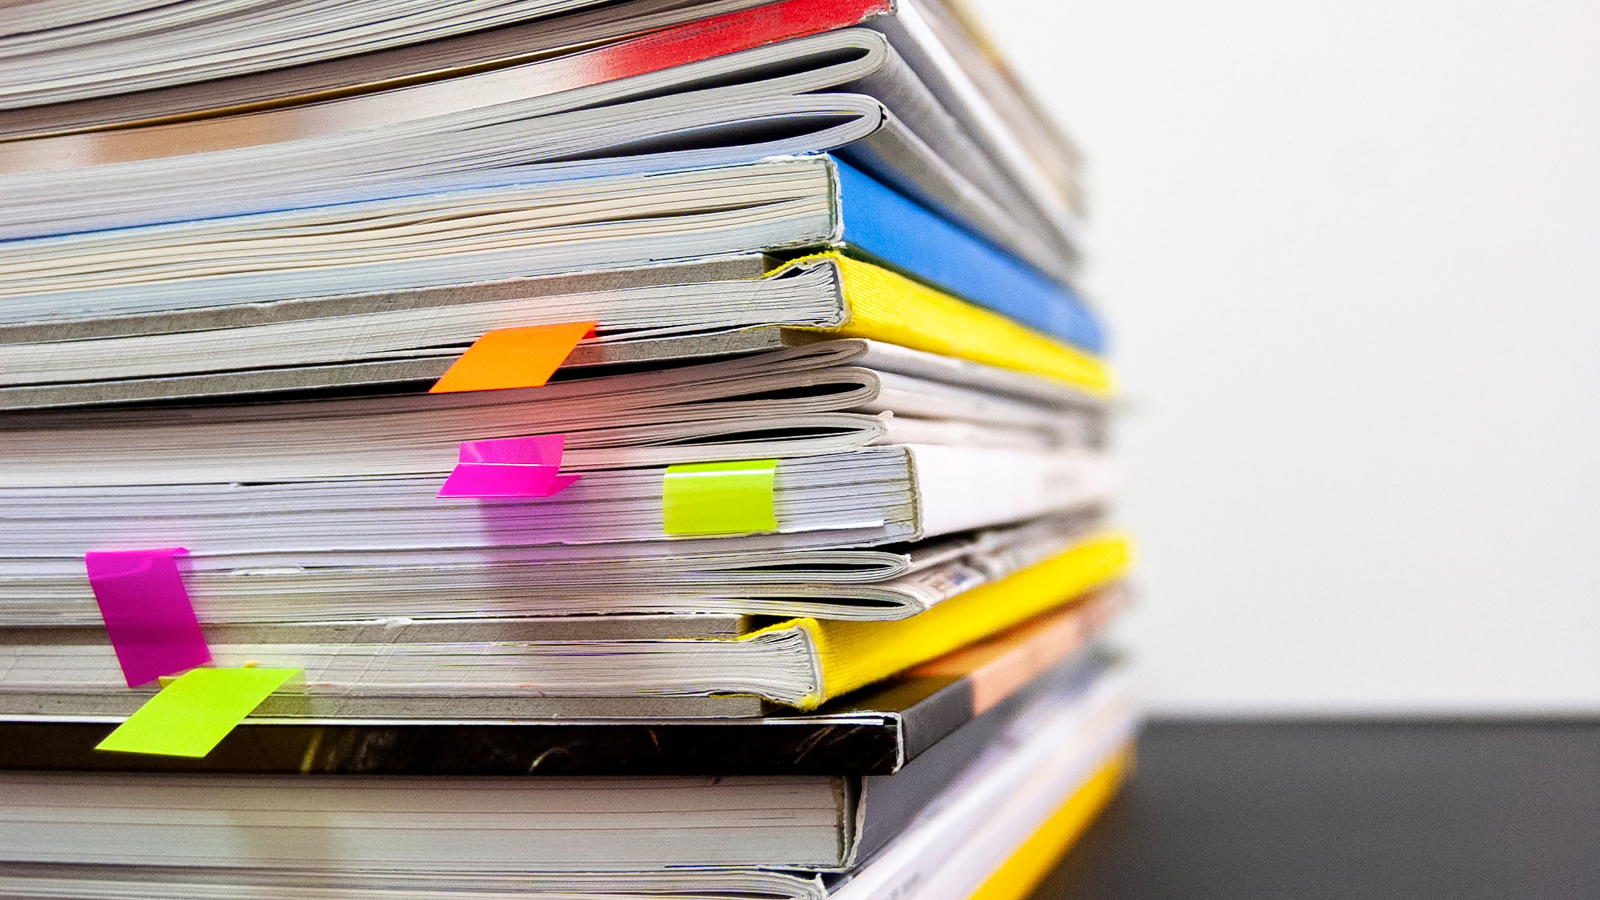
<box><xmin>773</xmin><ymin>251</ymin><xmax>1115</xmax><ymax>397</ymax></box>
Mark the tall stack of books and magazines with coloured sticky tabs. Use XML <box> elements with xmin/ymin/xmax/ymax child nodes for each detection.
<box><xmin>0</xmin><ymin>0</ymin><xmax>1136</xmax><ymax>900</ymax></box>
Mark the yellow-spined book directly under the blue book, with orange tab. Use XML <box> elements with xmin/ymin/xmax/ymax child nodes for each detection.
<box><xmin>0</xmin><ymin>251</ymin><xmax>1112</xmax><ymax>408</ymax></box>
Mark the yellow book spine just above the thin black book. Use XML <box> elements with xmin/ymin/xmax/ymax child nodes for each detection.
<box><xmin>741</xmin><ymin>532</ymin><xmax>1133</xmax><ymax>709</ymax></box>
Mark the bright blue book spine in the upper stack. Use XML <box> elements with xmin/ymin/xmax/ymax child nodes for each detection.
<box><xmin>834</xmin><ymin>157</ymin><xmax>1106</xmax><ymax>354</ymax></box>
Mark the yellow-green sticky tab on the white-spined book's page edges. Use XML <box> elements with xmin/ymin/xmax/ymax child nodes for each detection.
<box><xmin>661</xmin><ymin>460</ymin><xmax>778</xmax><ymax>535</ymax></box>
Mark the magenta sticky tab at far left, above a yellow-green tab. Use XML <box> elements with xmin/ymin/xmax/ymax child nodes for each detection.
<box><xmin>83</xmin><ymin>548</ymin><xmax>211</xmax><ymax>687</ymax></box>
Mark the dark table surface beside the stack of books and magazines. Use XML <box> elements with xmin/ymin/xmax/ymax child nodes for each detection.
<box><xmin>1035</xmin><ymin>721</ymin><xmax>1600</xmax><ymax>900</ymax></box>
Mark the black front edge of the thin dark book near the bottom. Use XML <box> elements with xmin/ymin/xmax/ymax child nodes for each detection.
<box><xmin>0</xmin><ymin>716</ymin><xmax>904</xmax><ymax>777</ymax></box>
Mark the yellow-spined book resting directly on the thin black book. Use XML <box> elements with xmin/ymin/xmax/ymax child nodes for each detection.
<box><xmin>0</xmin><ymin>533</ymin><xmax>1130</xmax><ymax>717</ymax></box>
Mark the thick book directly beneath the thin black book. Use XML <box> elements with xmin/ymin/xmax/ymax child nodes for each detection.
<box><xmin>0</xmin><ymin>643</ymin><xmax>1133</xmax><ymax>884</ymax></box>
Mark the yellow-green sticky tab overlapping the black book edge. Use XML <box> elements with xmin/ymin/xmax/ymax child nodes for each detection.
<box><xmin>94</xmin><ymin>666</ymin><xmax>301</xmax><ymax>756</ymax></box>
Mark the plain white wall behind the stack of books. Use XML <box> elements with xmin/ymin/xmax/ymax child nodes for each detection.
<box><xmin>971</xmin><ymin>0</ymin><xmax>1600</xmax><ymax>714</ymax></box>
